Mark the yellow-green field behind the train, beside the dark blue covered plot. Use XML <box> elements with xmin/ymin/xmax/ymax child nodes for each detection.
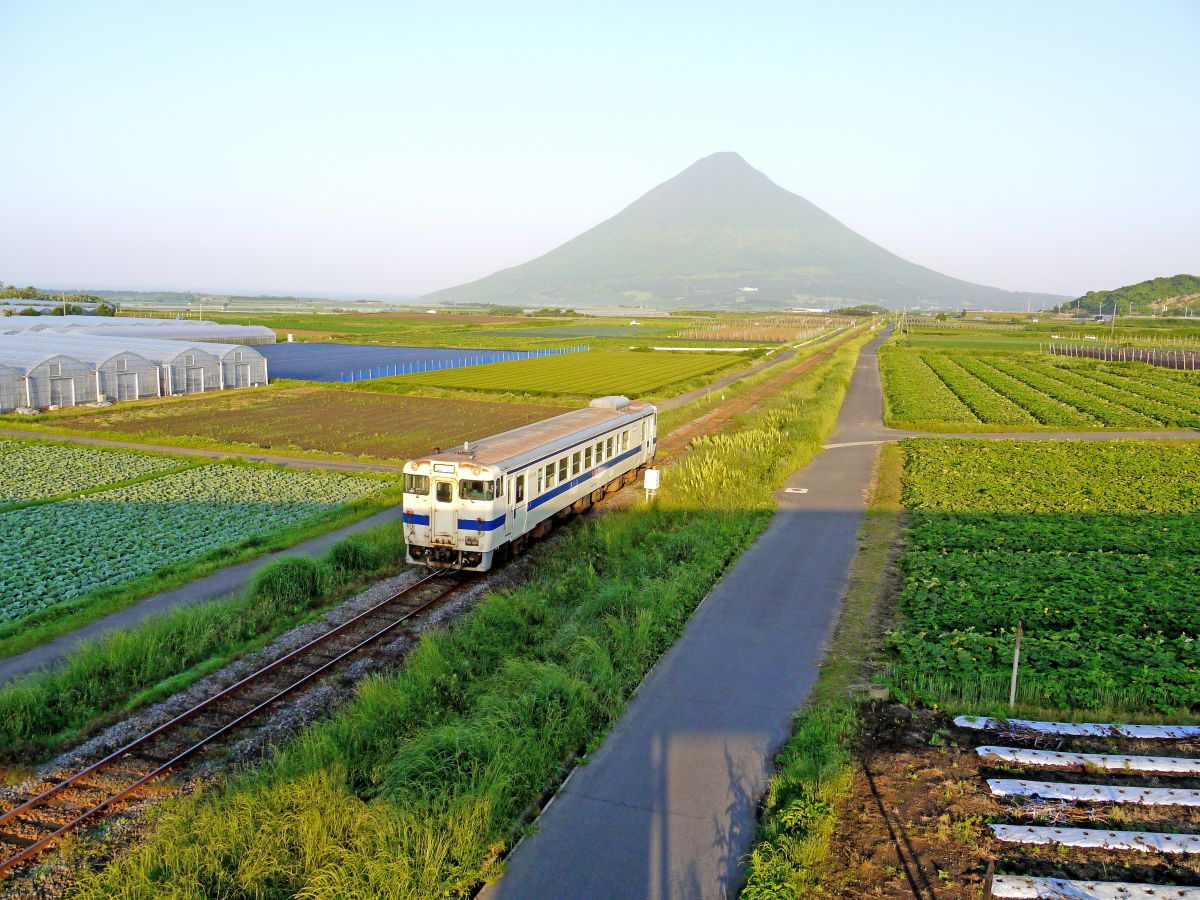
<box><xmin>379</xmin><ymin>350</ymin><xmax>742</xmax><ymax>397</ymax></box>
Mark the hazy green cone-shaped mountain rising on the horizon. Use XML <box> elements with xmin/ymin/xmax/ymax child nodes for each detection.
<box><xmin>428</xmin><ymin>152</ymin><xmax>1066</xmax><ymax>308</ymax></box>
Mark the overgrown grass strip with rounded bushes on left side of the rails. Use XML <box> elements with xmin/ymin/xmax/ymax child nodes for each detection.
<box><xmin>0</xmin><ymin>523</ymin><xmax>404</xmax><ymax>762</ymax></box>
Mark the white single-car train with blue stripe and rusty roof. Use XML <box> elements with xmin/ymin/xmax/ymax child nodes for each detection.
<box><xmin>403</xmin><ymin>397</ymin><xmax>658</xmax><ymax>571</ymax></box>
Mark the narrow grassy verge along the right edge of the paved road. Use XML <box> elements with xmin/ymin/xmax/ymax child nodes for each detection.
<box><xmin>742</xmin><ymin>444</ymin><xmax>904</xmax><ymax>900</ymax></box>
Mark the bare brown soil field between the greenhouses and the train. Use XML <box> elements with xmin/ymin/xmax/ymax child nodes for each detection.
<box><xmin>14</xmin><ymin>386</ymin><xmax>564</xmax><ymax>460</ymax></box>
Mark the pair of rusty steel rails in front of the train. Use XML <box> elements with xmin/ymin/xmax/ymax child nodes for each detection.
<box><xmin>0</xmin><ymin>571</ymin><xmax>460</xmax><ymax>872</ymax></box>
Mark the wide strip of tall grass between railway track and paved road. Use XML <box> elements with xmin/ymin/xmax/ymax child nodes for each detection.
<box><xmin>80</xmin><ymin>336</ymin><xmax>858</xmax><ymax>898</ymax></box>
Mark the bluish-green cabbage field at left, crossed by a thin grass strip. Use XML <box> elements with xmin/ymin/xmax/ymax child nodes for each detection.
<box><xmin>0</xmin><ymin>442</ymin><xmax>390</xmax><ymax>624</ymax></box>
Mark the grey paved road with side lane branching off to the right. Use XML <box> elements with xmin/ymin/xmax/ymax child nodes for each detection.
<box><xmin>482</xmin><ymin>332</ymin><xmax>1200</xmax><ymax>900</ymax></box>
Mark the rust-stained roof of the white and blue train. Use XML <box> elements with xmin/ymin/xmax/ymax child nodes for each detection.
<box><xmin>414</xmin><ymin>397</ymin><xmax>655</xmax><ymax>469</ymax></box>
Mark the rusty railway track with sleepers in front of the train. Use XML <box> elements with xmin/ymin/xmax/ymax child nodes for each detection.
<box><xmin>0</xmin><ymin>572</ymin><xmax>468</xmax><ymax>875</ymax></box>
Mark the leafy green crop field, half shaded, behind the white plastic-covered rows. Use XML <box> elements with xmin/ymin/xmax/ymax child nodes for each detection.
<box><xmin>890</xmin><ymin>439</ymin><xmax>1200</xmax><ymax>714</ymax></box>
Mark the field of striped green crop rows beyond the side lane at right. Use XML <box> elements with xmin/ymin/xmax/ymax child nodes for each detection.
<box><xmin>881</xmin><ymin>349</ymin><xmax>1200</xmax><ymax>430</ymax></box>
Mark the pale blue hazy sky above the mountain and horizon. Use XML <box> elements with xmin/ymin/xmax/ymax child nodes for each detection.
<box><xmin>0</xmin><ymin>0</ymin><xmax>1200</xmax><ymax>295</ymax></box>
